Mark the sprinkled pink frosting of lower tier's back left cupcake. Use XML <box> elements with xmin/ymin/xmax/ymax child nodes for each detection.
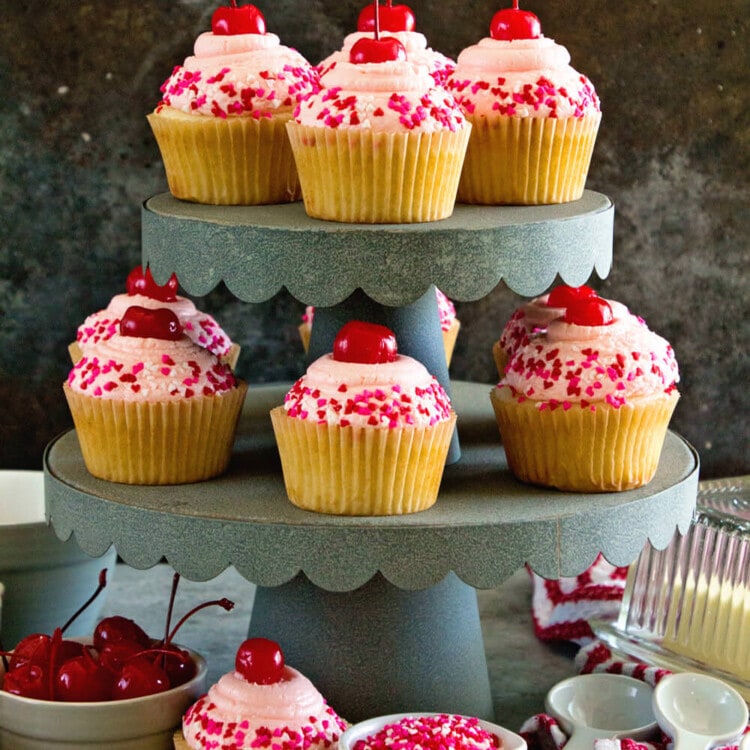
<box><xmin>76</xmin><ymin>294</ymin><xmax>232</xmax><ymax>357</ymax></box>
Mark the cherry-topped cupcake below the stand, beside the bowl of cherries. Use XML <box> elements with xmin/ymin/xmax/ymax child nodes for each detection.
<box><xmin>174</xmin><ymin>638</ymin><xmax>347</xmax><ymax>750</ymax></box>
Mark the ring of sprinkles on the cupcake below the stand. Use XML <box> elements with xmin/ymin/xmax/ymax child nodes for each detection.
<box><xmin>185</xmin><ymin>695</ymin><xmax>346</xmax><ymax>750</ymax></box>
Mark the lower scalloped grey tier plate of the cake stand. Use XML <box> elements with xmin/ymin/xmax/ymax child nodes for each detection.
<box><xmin>45</xmin><ymin>382</ymin><xmax>698</xmax><ymax>591</ymax></box>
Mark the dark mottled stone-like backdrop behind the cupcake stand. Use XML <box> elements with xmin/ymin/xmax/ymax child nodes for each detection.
<box><xmin>0</xmin><ymin>0</ymin><xmax>750</xmax><ymax>478</ymax></box>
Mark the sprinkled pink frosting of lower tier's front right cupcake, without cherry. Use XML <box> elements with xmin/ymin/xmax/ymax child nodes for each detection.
<box><xmin>498</xmin><ymin>303</ymin><xmax>679</xmax><ymax>409</ymax></box>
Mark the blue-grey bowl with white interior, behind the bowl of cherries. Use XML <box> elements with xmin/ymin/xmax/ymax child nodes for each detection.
<box><xmin>0</xmin><ymin>471</ymin><xmax>117</xmax><ymax>649</ymax></box>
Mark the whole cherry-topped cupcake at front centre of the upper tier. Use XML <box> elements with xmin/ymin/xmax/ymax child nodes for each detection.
<box><xmin>287</xmin><ymin>25</ymin><xmax>471</xmax><ymax>224</ymax></box>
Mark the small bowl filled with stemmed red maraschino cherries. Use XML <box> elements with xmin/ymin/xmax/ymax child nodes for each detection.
<box><xmin>0</xmin><ymin>570</ymin><xmax>234</xmax><ymax>750</ymax></box>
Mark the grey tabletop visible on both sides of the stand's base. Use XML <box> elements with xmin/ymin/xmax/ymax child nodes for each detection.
<box><xmin>102</xmin><ymin>564</ymin><xmax>577</xmax><ymax>731</ymax></box>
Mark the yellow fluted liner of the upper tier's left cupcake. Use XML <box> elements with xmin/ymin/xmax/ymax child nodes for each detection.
<box><xmin>148</xmin><ymin>107</ymin><xmax>300</xmax><ymax>206</ymax></box>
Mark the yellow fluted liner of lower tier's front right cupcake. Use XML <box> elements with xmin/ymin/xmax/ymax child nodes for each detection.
<box><xmin>490</xmin><ymin>388</ymin><xmax>679</xmax><ymax>492</ymax></box>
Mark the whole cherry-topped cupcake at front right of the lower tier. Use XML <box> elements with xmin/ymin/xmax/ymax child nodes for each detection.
<box><xmin>490</xmin><ymin>297</ymin><xmax>679</xmax><ymax>492</ymax></box>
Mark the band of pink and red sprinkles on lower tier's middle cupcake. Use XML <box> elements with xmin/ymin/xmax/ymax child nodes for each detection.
<box><xmin>284</xmin><ymin>377</ymin><xmax>451</xmax><ymax>429</ymax></box>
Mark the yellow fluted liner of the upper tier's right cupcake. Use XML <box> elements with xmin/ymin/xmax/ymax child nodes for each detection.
<box><xmin>457</xmin><ymin>112</ymin><xmax>601</xmax><ymax>206</ymax></box>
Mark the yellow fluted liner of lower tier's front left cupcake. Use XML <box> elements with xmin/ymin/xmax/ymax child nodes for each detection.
<box><xmin>63</xmin><ymin>381</ymin><xmax>247</xmax><ymax>484</ymax></box>
